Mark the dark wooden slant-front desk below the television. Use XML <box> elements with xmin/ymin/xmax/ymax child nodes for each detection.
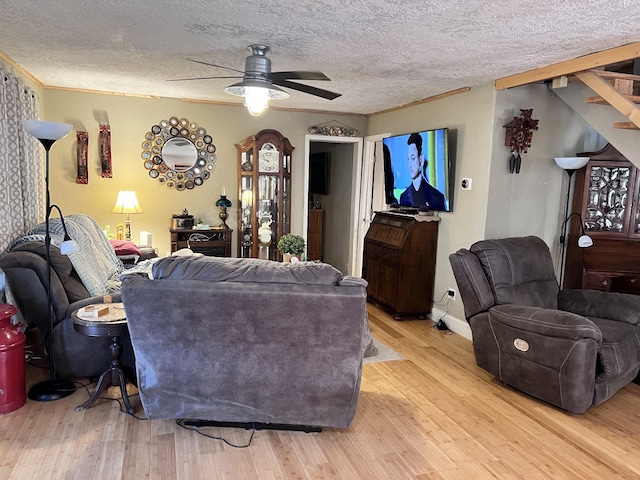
<box><xmin>362</xmin><ymin>212</ymin><xmax>439</xmax><ymax>320</ymax></box>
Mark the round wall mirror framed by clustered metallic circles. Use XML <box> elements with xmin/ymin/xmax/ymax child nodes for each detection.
<box><xmin>142</xmin><ymin>117</ymin><xmax>216</xmax><ymax>190</ymax></box>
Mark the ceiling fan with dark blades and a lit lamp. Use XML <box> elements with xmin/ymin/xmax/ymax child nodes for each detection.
<box><xmin>170</xmin><ymin>44</ymin><xmax>341</xmax><ymax>115</ymax></box>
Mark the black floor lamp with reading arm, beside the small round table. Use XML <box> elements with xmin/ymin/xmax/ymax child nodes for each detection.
<box><xmin>22</xmin><ymin>120</ymin><xmax>78</xmax><ymax>402</ymax></box>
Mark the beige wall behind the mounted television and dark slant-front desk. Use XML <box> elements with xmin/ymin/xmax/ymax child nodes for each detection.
<box><xmin>368</xmin><ymin>85</ymin><xmax>495</xmax><ymax>319</ymax></box>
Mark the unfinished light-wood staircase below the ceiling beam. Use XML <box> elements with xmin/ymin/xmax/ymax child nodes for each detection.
<box><xmin>574</xmin><ymin>69</ymin><xmax>640</xmax><ymax>130</ymax></box>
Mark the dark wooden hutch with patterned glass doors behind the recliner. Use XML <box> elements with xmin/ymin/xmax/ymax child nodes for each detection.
<box><xmin>564</xmin><ymin>145</ymin><xmax>640</xmax><ymax>294</ymax></box>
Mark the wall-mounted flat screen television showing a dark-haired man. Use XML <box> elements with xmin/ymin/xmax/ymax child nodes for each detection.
<box><xmin>382</xmin><ymin>128</ymin><xmax>454</xmax><ymax>212</ymax></box>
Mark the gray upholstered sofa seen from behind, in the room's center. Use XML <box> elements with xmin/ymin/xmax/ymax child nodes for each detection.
<box><xmin>121</xmin><ymin>257</ymin><xmax>371</xmax><ymax>428</ymax></box>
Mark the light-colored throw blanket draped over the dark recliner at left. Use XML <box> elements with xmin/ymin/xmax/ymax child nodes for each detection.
<box><xmin>9</xmin><ymin>214</ymin><xmax>124</xmax><ymax>296</ymax></box>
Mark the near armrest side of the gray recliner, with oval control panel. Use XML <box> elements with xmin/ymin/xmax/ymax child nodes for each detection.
<box><xmin>488</xmin><ymin>304</ymin><xmax>602</xmax><ymax>413</ymax></box>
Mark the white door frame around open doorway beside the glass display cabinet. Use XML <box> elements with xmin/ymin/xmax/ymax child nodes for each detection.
<box><xmin>302</xmin><ymin>134</ymin><xmax>363</xmax><ymax>276</ymax></box>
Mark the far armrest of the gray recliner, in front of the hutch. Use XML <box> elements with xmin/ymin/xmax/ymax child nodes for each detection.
<box><xmin>558</xmin><ymin>289</ymin><xmax>640</xmax><ymax>325</ymax></box>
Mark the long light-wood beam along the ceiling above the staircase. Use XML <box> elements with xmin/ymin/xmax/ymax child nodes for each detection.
<box><xmin>496</xmin><ymin>42</ymin><xmax>640</xmax><ymax>90</ymax></box>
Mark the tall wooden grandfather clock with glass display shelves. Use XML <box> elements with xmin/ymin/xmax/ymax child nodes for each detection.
<box><xmin>236</xmin><ymin>130</ymin><xmax>294</xmax><ymax>260</ymax></box>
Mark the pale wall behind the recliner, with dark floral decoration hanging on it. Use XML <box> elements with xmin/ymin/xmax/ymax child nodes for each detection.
<box><xmin>485</xmin><ymin>84</ymin><xmax>602</xmax><ymax>272</ymax></box>
